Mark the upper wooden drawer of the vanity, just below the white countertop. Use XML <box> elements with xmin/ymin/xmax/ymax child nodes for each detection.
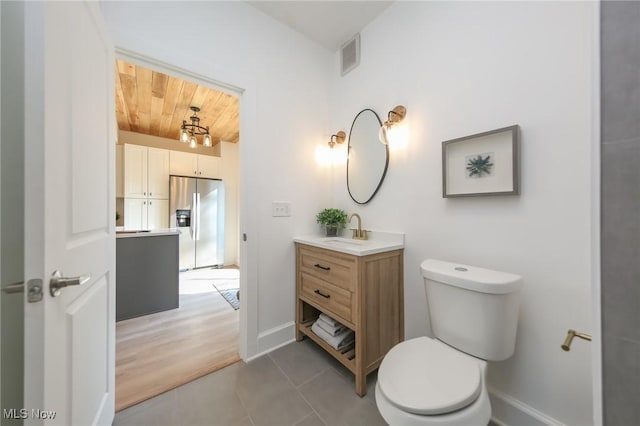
<box><xmin>300</xmin><ymin>248</ymin><xmax>356</xmax><ymax>291</ymax></box>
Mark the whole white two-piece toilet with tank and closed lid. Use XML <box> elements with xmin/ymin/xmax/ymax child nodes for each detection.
<box><xmin>376</xmin><ymin>259</ymin><xmax>522</xmax><ymax>426</ymax></box>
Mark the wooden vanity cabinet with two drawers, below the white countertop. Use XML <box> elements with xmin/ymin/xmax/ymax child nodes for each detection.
<box><xmin>295</xmin><ymin>242</ymin><xmax>404</xmax><ymax>396</ymax></box>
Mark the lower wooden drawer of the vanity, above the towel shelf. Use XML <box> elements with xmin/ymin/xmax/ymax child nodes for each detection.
<box><xmin>300</xmin><ymin>272</ymin><xmax>355</xmax><ymax>324</ymax></box>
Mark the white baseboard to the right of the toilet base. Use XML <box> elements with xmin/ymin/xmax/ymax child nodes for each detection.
<box><xmin>489</xmin><ymin>388</ymin><xmax>563</xmax><ymax>426</ymax></box>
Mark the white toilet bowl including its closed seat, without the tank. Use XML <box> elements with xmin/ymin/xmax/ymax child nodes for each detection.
<box><xmin>375</xmin><ymin>337</ymin><xmax>491</xmax><ymax>426</ymax></box>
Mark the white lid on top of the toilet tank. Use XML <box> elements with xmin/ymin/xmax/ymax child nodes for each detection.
<box><xmin>420</xmin><ymin>259</ymin><xmax>522</xmax><ymax>294</ymax></box>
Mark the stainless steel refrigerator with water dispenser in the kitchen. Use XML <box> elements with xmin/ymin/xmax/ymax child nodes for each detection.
<box><xmin>169</xmin><ymin>176</ymin><xmax>224</xmax><ymax>270</ymax></box>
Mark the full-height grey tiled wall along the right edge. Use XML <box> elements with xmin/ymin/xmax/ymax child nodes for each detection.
<box><xmin>600</xmin><ymin>1</ymin><xmax>640</xmax><ymax>425</ymax></box>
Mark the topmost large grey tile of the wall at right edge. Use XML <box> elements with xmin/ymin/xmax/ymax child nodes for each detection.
<box><xmin>601</xmin><ymin>1</ymin><xmax>640</xmax><ymax>142</ymax></box>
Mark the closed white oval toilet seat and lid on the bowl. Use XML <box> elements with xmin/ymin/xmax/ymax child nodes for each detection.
<box><xmin>378</xmin><ymin>337</ymin><xmax>482</xmax><ymax>415</ymax></box>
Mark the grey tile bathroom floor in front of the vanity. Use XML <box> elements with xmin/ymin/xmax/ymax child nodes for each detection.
<box><xmin>113</xmin><ymin>339</ymin><xmax>385</xmax><ymax>426</ymax></box>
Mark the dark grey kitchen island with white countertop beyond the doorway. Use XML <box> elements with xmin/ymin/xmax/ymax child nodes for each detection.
<box><xmin>116</xmin><ymin>228</ymin><xmax>179</xmax><ymax>321</ymax></box>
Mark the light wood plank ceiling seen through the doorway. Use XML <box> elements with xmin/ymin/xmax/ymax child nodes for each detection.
<box><xmin>115</xmin><ymin>60</ymin><xmax>240</xmax><ymax>143</ymax></box>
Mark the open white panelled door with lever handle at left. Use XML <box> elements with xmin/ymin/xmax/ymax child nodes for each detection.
<box><xmin>24</xmin><ymin>2</ymin><xmax>115</xmax><ymax>425</ymax></box>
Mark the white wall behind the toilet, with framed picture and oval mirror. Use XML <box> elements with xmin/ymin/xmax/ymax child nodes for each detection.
<box><xmin>330</xmin><ymin>2</ymin><xmax>594</xmax><ymax>425</ymax></box>
